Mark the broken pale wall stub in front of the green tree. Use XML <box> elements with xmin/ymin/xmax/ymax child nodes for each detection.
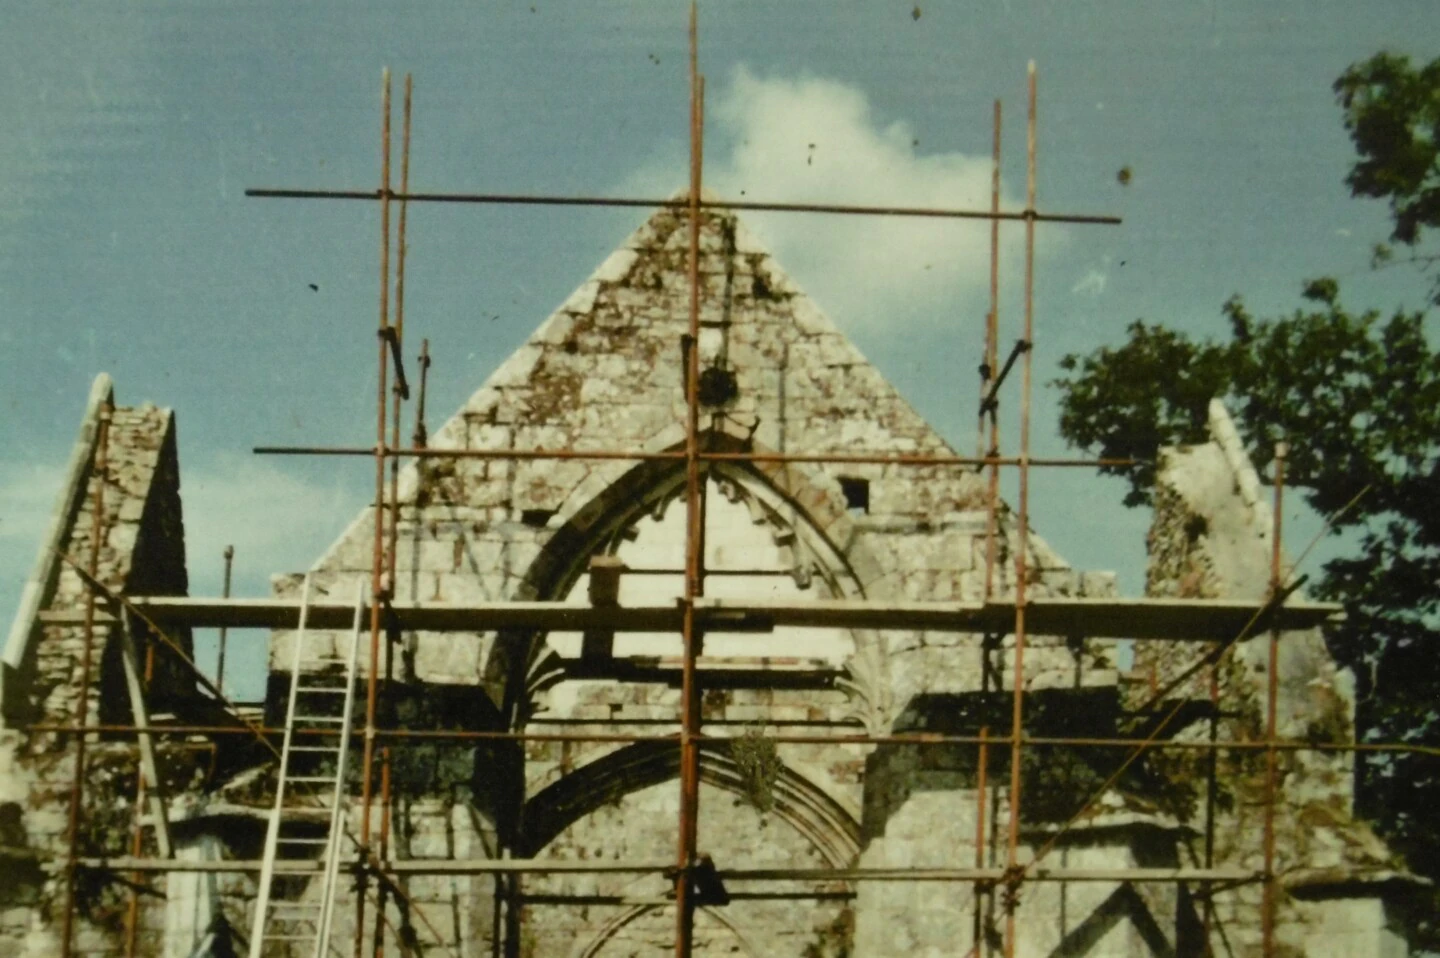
<box><xmin>1135</xmin><ymin>400</ymin><xmax>1422</xmax><ymax>910</ymax></box>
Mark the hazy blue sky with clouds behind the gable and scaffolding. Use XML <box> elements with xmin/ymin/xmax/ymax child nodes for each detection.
<box><xmin>0</xmin><ymin>0</ymin><xmax>1440</xmax><ymax>700</ymax></box>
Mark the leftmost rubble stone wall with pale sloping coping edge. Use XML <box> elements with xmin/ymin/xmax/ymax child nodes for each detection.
<box><xmin>0</xmin><ymin>405</ymin><xmax>193</xmax><ymax>958</ymax></box>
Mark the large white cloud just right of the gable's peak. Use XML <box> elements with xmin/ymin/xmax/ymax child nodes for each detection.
<box><xmin>626</xmin><ymin>66</ymin><xmax>1054</xmax><ymax>330</ymax></box>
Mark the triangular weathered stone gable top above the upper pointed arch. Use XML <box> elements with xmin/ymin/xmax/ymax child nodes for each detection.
<box><xmin>317</xmin><ymin>193</ymin><xmax>1036</xmax><ymax>582</ymax></box>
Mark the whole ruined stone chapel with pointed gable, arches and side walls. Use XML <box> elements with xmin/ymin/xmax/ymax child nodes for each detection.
<box><xmin>0</xmin><ymin>200</ymin><xmax>1418</xmax><ymax>958</ymax></box>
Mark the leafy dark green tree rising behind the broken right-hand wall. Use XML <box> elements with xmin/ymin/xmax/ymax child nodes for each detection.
<box><xmin>1054</xmin><ymin>53</ymin><xmax>1440</xmax><ymax>939</ymax></box>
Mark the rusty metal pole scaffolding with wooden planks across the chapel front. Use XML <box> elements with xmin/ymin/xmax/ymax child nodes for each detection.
<box><xmin>30</xmin><ymin>10</ymin><xmax>1433</xmax><ymax>958</ymax></box>
